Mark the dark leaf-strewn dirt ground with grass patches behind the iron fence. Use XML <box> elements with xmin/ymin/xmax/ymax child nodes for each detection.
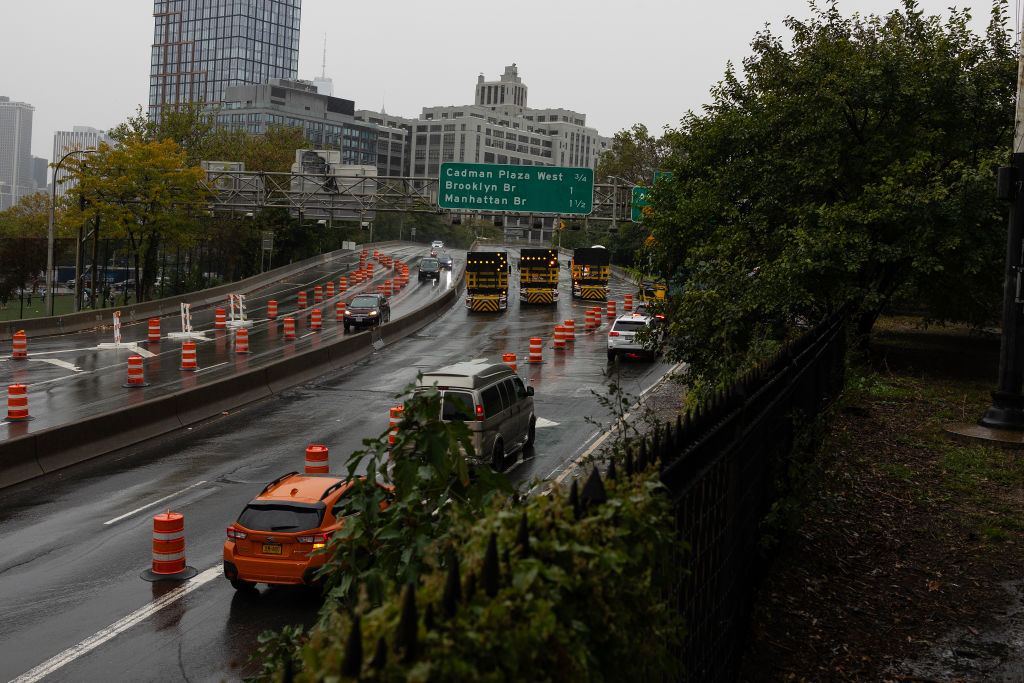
<box><xmin>741</xmin><ymin>319</ymin><xmax>1024</xmax><ymax>682</ymax></box>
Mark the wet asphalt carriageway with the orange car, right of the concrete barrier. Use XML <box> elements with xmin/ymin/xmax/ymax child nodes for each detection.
<box><xmin>0</xmin><ymin>245</ymin><xmax>669</xmax><ymax>681</ymax></box>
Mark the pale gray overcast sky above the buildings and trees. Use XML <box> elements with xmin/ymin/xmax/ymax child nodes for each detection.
<box><xmin>0</xmin><ymin>0</ymin><xmax>1007</xmax><ymax>159</ymax></box>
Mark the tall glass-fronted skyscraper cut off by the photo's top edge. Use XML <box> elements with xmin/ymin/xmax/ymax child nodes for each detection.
<box><xmin>150</xmin><ymin>0</ymin><xmax>302</xmax><ymax>119</ymax></box>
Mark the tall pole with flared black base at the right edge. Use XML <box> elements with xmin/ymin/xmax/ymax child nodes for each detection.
<box><xmin>978</xmin><ymin>22</ymin><xmax>1024</xmax><ymax>431</ymax></box>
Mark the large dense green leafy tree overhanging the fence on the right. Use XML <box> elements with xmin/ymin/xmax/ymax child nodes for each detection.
<box><xmin>644</xmin><ymin>0</ymin><xmax>1017</xmax><ymax>388</ymax></box>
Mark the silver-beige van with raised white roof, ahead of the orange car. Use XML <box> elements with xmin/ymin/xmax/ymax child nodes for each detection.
<box><xmin>418</xmin><ymin>358</ymin><xmax>537</xmax><ymax>472</ymax></box>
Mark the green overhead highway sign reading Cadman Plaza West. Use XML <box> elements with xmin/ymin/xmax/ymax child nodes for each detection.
<box><xmin>437</xmin><ymin>164</ymin><xmax>594</xmax><ymax>215</ymax></box>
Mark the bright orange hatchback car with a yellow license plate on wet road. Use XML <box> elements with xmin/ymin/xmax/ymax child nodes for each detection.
<box><xmin>224</xmin><ymin>472</ymin><xmax>391</xmax><ymax>590</ymax></box>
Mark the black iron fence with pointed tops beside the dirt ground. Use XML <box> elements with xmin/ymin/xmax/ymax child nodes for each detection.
<box><xmin>655</xmin><ymin>315</ymin><xmax>846</xmax><ymax>681</ymax></box>
